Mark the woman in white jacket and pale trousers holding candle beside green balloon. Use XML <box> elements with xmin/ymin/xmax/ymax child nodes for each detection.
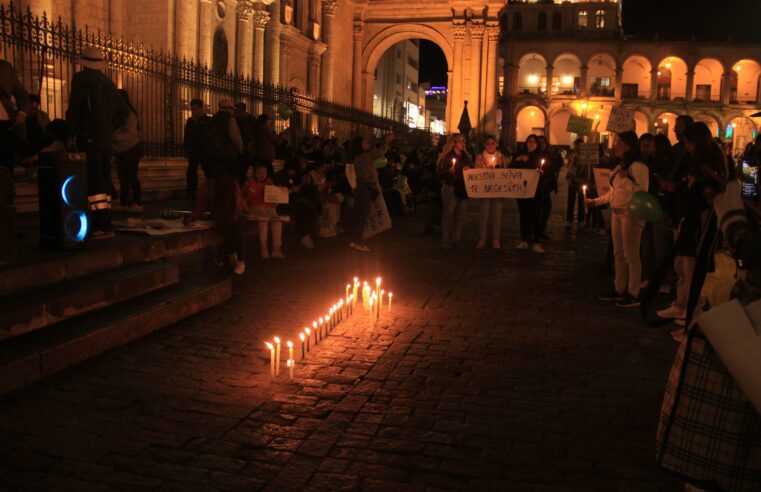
<box><xmin>587</xmin><ymin>132</ymin><xmax>649</xmax><ymax>307</ymax></box>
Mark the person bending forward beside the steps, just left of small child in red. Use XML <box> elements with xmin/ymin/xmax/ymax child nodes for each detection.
<box><xmin>183</xmin><ymin>166</ymin><xmax>247</xmax><ymax>275</ymax></box>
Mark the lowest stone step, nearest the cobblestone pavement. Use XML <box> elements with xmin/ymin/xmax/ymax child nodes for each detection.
<box><xmin>0</xmin><ymin>273</ymin><xmax>231</xmax><ymax>394</ymax></box>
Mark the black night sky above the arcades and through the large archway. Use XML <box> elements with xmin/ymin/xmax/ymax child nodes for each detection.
<box><xmin>420</xmin><ymin>0</ymin><xmax>761</xmax><ymax>85</ymax></box>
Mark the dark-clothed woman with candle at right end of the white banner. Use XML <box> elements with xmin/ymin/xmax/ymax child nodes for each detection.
<box><xmin>511</xmin><ymin>134</ymin><xmax>550</xmax><ymax>253</ymax></box>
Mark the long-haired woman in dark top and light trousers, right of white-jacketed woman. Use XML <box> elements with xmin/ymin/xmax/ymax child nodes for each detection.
<box><xmin>657</xmin><ymin>122</ymin><xmax>728</xmax><ymax>325</ymax></box>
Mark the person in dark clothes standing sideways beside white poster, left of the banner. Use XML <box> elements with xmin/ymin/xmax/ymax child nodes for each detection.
<box><xmin>349</xmin><ymin>136</ymin><xmax>381</xmax><ymax>253</ymax></box>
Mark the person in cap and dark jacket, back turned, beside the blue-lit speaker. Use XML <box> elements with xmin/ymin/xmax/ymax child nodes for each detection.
<box><xmin>66</xmin><ymin>47</ymin><xmax>130</xmax><ymax>239</ymax></box>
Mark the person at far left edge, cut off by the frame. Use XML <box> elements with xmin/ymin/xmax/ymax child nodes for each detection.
<box><xmin>0</xmin><ymin>60</ymin><xmax>29</xmax><ymax>188</ymax></box>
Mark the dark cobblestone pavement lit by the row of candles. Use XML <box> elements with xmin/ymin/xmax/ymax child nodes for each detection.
<box><xmin>0</xmin><ymin>199</ymin><xmax>680</xmax><ymax>492</ymax></box>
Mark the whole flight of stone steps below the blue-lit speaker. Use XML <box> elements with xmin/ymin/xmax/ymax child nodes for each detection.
<box><xmin>0</xmin><ymin>230</ymin><xmax>231</xmax><ymax>394</ymax></box>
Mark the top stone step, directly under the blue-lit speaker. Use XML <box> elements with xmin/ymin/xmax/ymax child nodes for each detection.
<box><xmin>0</xmin><ymin>229</ymin><xmax>220</xmax><ymax>296</ymax></box>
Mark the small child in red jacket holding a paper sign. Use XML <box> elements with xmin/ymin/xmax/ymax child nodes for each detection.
<box><xmin>243</xmin><ymin>162</ymin><xmax>285</xmax><ymax>260</ymax></box>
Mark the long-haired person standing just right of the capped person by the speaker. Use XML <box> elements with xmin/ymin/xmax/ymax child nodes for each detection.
<box><xmin>113</xmin><ymin>89</ymin><xmax>143</xmax><ymax>212</ymax></box>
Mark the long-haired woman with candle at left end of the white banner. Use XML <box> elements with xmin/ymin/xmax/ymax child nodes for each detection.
<box><xmin>437</xmin><ymin>133</ymin><xmax>473</xmax><ymax>249</ymax></box>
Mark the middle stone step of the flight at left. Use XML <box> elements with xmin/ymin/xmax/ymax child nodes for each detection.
<box><xmin>0</xmin><ymin>261</ymin><xmax>180</xmax><ymax>341</ymax></box>
